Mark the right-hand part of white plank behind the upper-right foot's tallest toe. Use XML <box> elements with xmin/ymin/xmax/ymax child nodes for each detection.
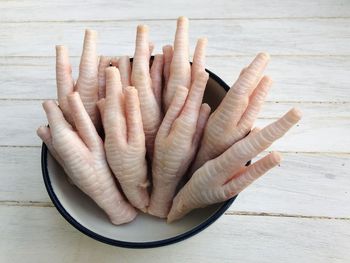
<box><xmin>207</xmin><ymin>56</ymin><xmax>350</xmax><ymax>102</ymax></box>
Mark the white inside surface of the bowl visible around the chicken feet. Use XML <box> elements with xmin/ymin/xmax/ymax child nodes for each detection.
<box><xmin>44</xmin><ymin>74</ymin><xmax>233</xmax><ymax>248</ymax></box>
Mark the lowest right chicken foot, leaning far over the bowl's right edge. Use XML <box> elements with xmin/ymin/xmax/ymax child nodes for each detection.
<box><xmin>168</xmin><ymin>109</ymin><xmax>301</xmax><ymax>222</ymax></box>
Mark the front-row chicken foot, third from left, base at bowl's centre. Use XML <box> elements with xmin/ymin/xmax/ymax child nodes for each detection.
<box><xmin>148</xmin><ymin>72</ymin><xmax>210</xmax><ymax>218</ymax></box>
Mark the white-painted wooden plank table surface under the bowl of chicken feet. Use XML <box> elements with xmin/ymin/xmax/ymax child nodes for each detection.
<box><xmin>0</xmin><ymin>0</ymin><xmax>350</xmax><ymax>262</ymax></box>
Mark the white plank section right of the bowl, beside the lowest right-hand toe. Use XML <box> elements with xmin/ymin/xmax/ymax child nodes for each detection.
<box><xmin>230</xmin><ymin>153</ymin><xmax>350</xmax><ymax>218</ymax></box>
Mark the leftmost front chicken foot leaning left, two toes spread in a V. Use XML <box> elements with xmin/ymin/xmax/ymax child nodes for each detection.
<box><xmin>38</xmin><ymin>92</ymin><xmax>137</xmax><ymax>225</ymax></box>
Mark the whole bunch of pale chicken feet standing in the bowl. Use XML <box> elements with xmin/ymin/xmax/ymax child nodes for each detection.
<box><xmin>37</xmin><ymin>17</ymin><xmax>301</xmax><ymax>225</ymax></box>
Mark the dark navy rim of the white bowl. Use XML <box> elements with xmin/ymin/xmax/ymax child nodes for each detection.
<box><xmin>41</xmin><ymin>69</ymin><xmax>237</xmax><ymax>248</ymax></box>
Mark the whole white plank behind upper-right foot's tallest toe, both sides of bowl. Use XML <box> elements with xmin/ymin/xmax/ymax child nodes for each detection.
<box><xmin>0</xmin><ymin>56</ymin><xmax>350</xmax><ymax>102</ymax></box>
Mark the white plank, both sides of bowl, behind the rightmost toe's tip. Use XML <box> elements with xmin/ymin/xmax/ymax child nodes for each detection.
<box><xmin>0</xmin><ymin>100</ymin><xmax>350</xmax><ymax>153</ymax></box>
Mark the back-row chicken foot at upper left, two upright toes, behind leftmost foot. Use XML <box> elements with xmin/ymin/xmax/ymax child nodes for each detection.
<box><xmin>56</xmin><ymin>30</ymin><xmax>101</xmax><ymax>130</ymax></box>
